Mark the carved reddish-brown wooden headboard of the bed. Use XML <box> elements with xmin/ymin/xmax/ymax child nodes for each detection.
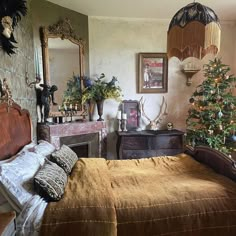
<box><xmin>0</xmin><ymin>103</ymin><xmax>32</xmax><ymax>160</ymax></box>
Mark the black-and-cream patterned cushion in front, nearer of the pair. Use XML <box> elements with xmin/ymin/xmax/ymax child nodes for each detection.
<box><xmin>34</xmin><ymin>161</ymin><xmax>67</xmax><ymax>201</ymax></box>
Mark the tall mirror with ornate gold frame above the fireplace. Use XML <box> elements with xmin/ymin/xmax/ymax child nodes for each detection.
<box><xmin>40</xmin><ymin>19</ymin><xmax>84</xmax><ymax>116</ymax></box>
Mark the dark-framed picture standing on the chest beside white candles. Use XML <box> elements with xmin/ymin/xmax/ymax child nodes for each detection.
<box><xmin>122</xmin><ymin>100</ymin><xmax>140</xmax><ymax>131</ymax></box>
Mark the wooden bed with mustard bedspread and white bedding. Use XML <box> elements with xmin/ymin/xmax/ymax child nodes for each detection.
<box><xmin>0</xmin><ymin>104</ymin><xmax>236</xmax><ymax>236</ymax></box>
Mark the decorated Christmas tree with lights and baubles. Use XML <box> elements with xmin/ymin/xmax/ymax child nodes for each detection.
<box><xmin>186</xmin><ymin>58</ymin><xmax>236</xmax><ymax>154</ymax></box>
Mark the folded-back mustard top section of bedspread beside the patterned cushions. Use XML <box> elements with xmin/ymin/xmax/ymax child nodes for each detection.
<box><xmin>41</xmin><ymin>158</ymin><xmax>117</xmax><ymax>236</ymax></box>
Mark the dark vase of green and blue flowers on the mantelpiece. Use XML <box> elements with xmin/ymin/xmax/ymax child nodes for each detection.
<box><xmin>82</xmin><ymin>73</ymin><xmax>121</xmax><ymax>121</ymax></box>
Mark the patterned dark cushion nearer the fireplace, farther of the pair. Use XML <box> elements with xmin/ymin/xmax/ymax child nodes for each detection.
<box><xmin>50</xmin><ymin>144</ymin><xmax>78</xmax><ymax>175</ymax></box>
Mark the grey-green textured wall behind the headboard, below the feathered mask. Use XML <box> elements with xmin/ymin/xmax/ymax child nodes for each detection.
<box><xmin>0</xmin><ymin>1</ymin><xmax>36</xmax><ymax>139</ymax></box>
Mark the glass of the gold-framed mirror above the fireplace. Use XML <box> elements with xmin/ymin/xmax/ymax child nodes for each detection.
<box><xmin>48</xmin><ymin>38</ymin><xmax>80</xmax><ymax>112</ymax></box>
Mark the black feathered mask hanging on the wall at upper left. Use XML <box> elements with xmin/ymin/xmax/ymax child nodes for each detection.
<box><xmin>0</xmin><ymin>0</ymin><xmax>27</xmax><ymax>56</ymax></box>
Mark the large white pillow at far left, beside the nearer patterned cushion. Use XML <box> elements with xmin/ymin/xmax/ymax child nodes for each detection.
<box><xmin>0</xmin><ymin>151</ymin><xmax>45</xmax><ymax>212</ymax></box>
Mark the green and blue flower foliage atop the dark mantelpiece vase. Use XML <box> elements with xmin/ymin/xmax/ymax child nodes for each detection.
<box><xmin>82</xmin><ymin>73</ymin><xmax>121</xmax><ymax>103</ymax></box>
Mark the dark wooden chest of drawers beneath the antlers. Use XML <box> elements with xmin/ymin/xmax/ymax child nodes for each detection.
<box><xmin>116</xmin><ymin>130</ymin><xmax>184</xmax><ymax>159</ymax></box>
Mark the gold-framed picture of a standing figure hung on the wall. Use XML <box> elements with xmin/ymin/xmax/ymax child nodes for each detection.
<box><xmin>138</xmin><ymin>53</ymin><xmax>168</xmax><ymax>93</ymax></box>
